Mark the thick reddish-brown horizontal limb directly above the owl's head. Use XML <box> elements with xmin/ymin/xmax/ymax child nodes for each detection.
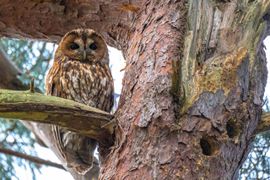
<box><xmin>0</xmin><ymin>0</ymin><xmax>141</xmax><ymax>45</ymax></box>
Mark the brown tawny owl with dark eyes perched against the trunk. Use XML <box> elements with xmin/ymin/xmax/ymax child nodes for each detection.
<box><xmin>46</xmin><ymin>29</ymin><xmax>114</xmax><ymax>174</ymax></box>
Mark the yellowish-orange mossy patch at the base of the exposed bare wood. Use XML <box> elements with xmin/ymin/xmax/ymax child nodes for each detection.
<box><xmin>180</xmin><ymin>48</ymin><xmax>248</xmax><ymax>114</ymax></box>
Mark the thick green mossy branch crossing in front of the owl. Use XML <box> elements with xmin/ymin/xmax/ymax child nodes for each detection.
<box><xmin>0</xmin><ymin>89</ymin><xmax>113</xmax><ymax>146</ymax></box>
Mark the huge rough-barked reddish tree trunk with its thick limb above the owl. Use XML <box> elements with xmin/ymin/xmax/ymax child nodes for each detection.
<box><xmin>0</xmin><ymin>0</ymin><xmax>270</xmax><ymax>179</ymax></box>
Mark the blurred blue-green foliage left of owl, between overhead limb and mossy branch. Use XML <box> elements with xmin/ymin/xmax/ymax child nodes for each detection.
<box><xmin>0</xmin><ymin>38</ymin><xmax>55</xmax><ymax>91</ymax></box>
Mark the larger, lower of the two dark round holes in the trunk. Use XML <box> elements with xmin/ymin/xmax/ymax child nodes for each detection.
<box><xmin>200</xmin><ymin>137</ymin><xmax>219</xmax><ymax>156</ymax></box>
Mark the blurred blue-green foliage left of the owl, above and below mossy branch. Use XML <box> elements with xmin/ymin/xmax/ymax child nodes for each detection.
<box><xmin>0</xmin><ymin>38</ymin><xmax>55</xmax><ymax>179</ymax></box>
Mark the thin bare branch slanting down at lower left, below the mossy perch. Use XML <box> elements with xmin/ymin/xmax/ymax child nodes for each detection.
<box><xmin>0</xmin><ymin>146</ymin><xmax>66</xmax><ymax>170</ymax></box>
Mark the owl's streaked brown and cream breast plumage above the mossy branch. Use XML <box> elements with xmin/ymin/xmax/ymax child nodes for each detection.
<box><xmin>60</xmin><ymin>61</ymin><xmax>113</xmax><ymax>111</ymax></box>
